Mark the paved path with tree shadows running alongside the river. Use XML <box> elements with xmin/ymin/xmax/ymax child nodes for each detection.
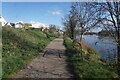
<box><xmin>14</xmin><ymin>36</ymin><xmax>72</xmax><ymax>78</ymax></box>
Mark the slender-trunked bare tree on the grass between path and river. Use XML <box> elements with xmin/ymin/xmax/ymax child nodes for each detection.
<box><xmin>71</xmin><ymin>2</ymin><xmax>101</xmax><ymax>56</ymax></box>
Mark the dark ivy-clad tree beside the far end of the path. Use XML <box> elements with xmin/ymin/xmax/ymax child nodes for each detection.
<box><xmin>63</xmin><ymin>5</ymin><xmax>76</xmax><ymax>39</ymax></box>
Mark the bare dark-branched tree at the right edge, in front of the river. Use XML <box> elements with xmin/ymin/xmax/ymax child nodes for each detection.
<box><xmin>97</xmin><ymin>0</ymin><xmax>120</xmax><ymax>72</ymax></box>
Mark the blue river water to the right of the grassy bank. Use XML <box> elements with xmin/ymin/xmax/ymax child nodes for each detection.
<box><xmin>76</xmin><ymin>35</ymin><xmax>117</xmax><ymax>61</ymax></box>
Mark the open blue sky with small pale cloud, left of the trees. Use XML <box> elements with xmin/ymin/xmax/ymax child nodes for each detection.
<box><xmin>2</xmin><ymin>2</ymin><xmax>71</xmax><ymax>26</ymax></box>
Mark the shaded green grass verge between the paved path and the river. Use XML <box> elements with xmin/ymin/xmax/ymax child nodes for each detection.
<box><xmin>64</xmin><ymin>37</ymin><xmax>118</xmax><ymax>79</ymax></box>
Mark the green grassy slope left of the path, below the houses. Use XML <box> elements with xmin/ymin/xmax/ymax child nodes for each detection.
<box><xmin>2</xmin><ymin>27</ymin><xmax>59</xmax><ymax>78</ymax></box>
